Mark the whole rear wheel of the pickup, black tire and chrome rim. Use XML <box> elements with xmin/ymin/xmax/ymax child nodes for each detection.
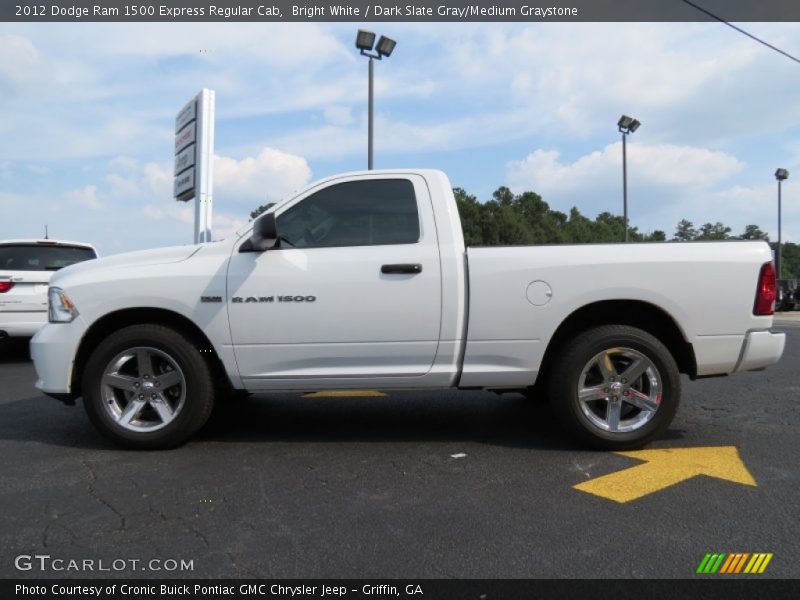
<box><xmin>548</xmin><ymin>325</ymin><xmax>681</xmax><ymax>450</ymax></box>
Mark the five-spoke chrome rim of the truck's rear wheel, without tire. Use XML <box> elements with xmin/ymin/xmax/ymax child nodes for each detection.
<box><xmin>577</xmin><ymin>347</ymin><xmax>663</xmax><ymax>433</ymax></box>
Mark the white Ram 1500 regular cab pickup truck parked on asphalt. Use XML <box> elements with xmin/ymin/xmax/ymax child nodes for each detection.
<box><xmin>31</xmin><ymin>170</ymin><xmax>785</xmax><ymax>449</ymax></box>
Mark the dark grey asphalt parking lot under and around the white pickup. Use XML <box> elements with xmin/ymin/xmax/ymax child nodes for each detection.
<box><xmin>0</xmin><ymin>319</ymin><xmax>800</xmax><ymax>578</ymax></box>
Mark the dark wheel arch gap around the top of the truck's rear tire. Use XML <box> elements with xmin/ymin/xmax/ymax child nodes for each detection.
<box><xmin>540</xmin><ymin>300</ymin><xmax>697</xmax><ymax>379</ymax></box>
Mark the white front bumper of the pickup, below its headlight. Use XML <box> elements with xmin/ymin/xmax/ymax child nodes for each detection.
<box><xmin>31</xmin><ymin>316</ymin><xmax>87</xmax><ymax>401</ymax></box>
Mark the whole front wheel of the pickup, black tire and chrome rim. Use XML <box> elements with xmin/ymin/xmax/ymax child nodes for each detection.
<box><xmin>82</xmin><ymin>325</ymin><xmax>215</xmax><ymax>450</ymax></box>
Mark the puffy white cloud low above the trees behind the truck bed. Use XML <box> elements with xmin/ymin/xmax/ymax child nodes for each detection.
<box><xmin>507</xmin><ymin>142</ymin><xmax>756</xmax><ymax>235</ymax></box>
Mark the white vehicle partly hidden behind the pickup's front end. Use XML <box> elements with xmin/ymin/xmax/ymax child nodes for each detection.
<box><xmin>0</xmin><ymin>240</ymin><xmax>97</xmax><ymax>341</ymax></box>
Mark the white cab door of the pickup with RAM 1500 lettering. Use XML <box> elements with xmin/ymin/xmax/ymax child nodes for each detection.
<box><xmin>227</xmin><ymin>175</ymin><xmax>441</xmax><ymax>389</ymax></box>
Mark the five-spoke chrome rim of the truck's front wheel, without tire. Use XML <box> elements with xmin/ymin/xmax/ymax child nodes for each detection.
<box><xmin>100</xmin><ymin>347</ymin><xmax>186</xmax><ymax>433</ymax></box>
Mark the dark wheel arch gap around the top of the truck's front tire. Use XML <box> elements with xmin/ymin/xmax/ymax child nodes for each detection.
<box><xmin>70</xmin><ymin>307</ymin><xmax>231</xmax><ymax>397</ymax></box>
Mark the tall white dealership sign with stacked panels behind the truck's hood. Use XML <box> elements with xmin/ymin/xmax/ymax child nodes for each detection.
<box><xmin>173</xmin><ymin>89</ymin><xmax>215</xmax><ymax>243</ymax></box>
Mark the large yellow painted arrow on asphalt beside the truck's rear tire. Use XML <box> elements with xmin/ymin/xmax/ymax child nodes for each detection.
<box><xmin>573</xmin><ymin>446</ymin><xmax>756</xmax><ymax>503</ymax></box>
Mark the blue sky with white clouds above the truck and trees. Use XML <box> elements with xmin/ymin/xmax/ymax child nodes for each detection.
<box><xmin>0</xmin><ymin>23</ymin><xmax>800</xmax><ymax>255</ymax></box>
